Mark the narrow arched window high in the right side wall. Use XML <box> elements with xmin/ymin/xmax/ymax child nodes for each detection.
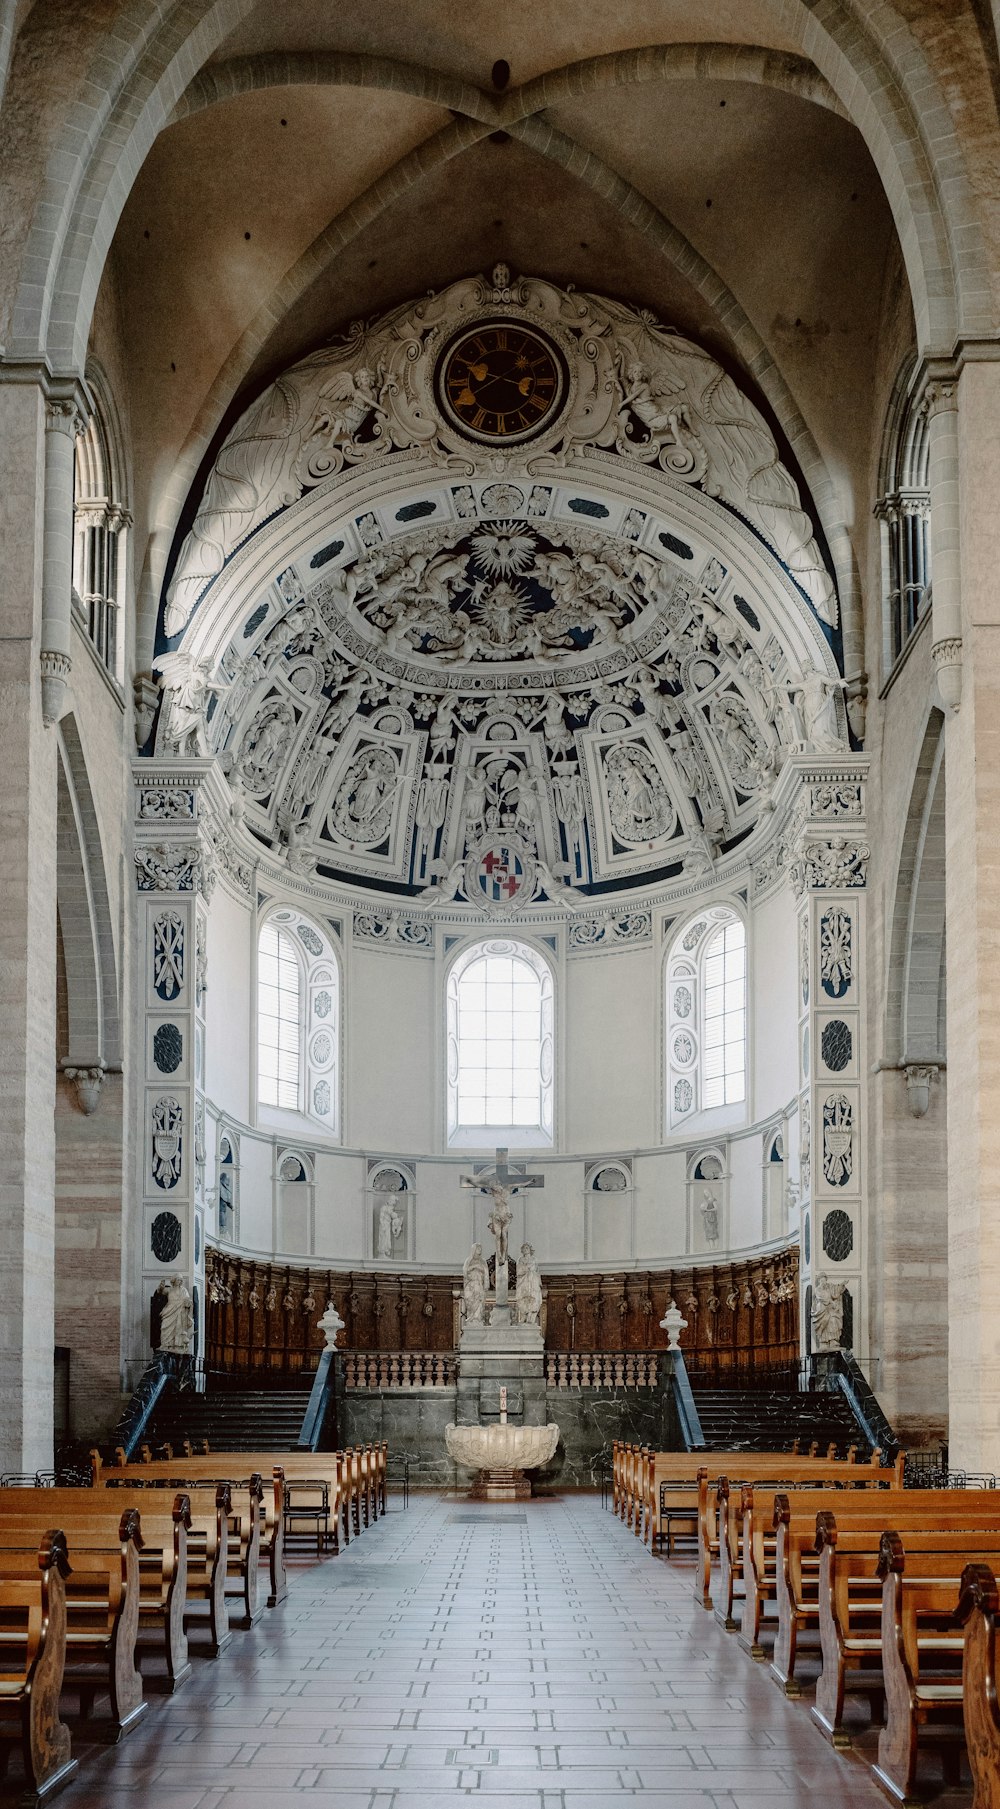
<box><xmin>875</xmin><ymin>362</ymin><xmax>931</xmax><ymax>666</ymax></box>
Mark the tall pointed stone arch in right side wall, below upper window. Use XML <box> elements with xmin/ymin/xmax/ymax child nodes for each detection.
<box><xmin>886</xmin><ymin>709</ymin><xmax>946</xmax><ymax>1066</ymax></box>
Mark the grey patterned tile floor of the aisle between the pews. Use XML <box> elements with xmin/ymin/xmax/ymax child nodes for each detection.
<box><xmin>58</xmin><ymin>1496</ymin><xmax>933</xmax><ymax>1809</ymax></box>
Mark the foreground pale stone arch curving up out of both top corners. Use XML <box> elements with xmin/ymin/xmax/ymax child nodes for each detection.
<box><xmin>11</xmin><ymin>0</ymin><xmax>991</xmax><ymax>369</ymax></box>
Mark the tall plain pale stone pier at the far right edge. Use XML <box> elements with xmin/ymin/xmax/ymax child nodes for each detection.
<box><xmin>931</xmin><ymin>362</ymin><xmax>1000</xmax><ymax>1473</ymax></box>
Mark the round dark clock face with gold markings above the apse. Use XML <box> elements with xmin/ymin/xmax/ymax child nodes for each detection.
<box><xmin>438</xmin><ymin>320</ymin><xmax>568</xmax><ymax>445</ymax></box>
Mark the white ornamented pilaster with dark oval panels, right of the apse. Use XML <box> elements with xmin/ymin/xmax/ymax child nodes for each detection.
<box><xmin>783</xmin><ymin>749</ymin><xmax>870</xmax><ymax>1360</ymax></box>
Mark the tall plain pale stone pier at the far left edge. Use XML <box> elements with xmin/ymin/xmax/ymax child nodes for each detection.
<box><xmin>0</xmin><ymin>378</ymin><xmax>58</xmax><ymax>1471</ymax></box>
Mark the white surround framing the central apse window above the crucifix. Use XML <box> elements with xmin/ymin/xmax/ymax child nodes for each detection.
<box><xmin>445</xmin><ymin>935</ymin><xmax>557</xmax><ymax>1151</ymax></box>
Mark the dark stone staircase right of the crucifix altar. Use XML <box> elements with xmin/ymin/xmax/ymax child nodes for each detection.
<box><xmin>691</xmin><ymin>1380</ymin><xmax>872</xmax><ymax>1458</ymax></box>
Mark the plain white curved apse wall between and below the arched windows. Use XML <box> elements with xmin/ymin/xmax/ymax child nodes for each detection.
<box><xmin>198</xmin><ymin>888</ymin><xmax>797</xmax><ymax>1270</ymax></box>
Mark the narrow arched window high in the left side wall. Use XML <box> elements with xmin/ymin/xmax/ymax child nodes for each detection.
<box><xmin>72</xmin><ymin>365</ymin><xmax>132</xmax><ymax>684</ymax></box>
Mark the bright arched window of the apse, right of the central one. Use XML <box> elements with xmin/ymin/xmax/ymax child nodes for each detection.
<box><xmin>665</xmin><ymin>905</ymin><xmax>747</xmax><ymax>1129</ymax></box>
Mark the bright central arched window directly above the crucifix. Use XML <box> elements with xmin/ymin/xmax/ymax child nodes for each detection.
<box><xmin>448</xmin><ymin>941</ymin><xmax>553</xmax><ymax>1147</ymax></box>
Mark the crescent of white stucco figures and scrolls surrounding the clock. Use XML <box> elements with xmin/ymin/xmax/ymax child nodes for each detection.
<box><xmin>166</xmin><ymin>266</ymin><xmax>835</xmax><ymax>635</ymax></box>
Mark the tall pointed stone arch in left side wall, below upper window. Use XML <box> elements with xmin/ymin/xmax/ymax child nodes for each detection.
<box><xmin>56</xmin><ymin>715</ymin><xmax>121</xmax><ymax>1069</ymax></box>
